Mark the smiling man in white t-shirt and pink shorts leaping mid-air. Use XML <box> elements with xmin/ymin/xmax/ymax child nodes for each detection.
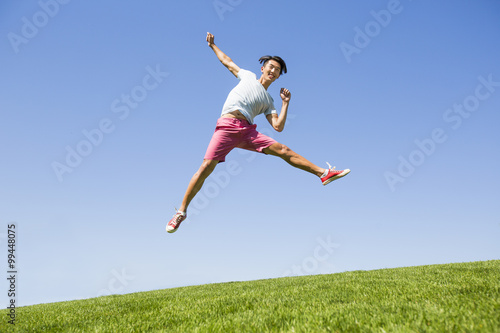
<box><xmin>166</xmin><ymin>33</ymin><xmax>350</xmax><ymax>233</ymax></box>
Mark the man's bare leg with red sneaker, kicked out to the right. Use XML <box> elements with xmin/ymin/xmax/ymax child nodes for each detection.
<box><xmin>262</xmin><ymin>142</ymin><xmax>351</xmax><ymax>185</ymax></box>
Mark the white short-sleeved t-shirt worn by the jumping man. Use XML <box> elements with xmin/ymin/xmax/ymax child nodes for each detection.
<box><xmin>221</xmin><ymin>69</ymin><xmax>277</xmax><ymax>124</ymax></box>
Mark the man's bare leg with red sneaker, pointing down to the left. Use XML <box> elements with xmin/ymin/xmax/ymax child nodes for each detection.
<box><xmin>166</xmin><ymin>159</ymin><xmax>219</xmax><ymax>233</ymax></box>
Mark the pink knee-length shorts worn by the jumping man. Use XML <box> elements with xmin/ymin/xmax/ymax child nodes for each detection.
<box><xmin>205</xmin><ymin>117</ymin><xmax>276</xmax><ymax>162</ymax></box>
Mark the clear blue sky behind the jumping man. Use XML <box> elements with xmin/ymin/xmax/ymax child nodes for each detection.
<box><xmin>0</xmin><ymin>0</ymin><xmax>500</xmax><ymax>305</ymax></box>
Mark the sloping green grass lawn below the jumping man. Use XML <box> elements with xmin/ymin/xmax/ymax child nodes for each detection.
<box><xmin>0</xmin><ymin>260</ymin><xmax>500</xmax><ymax>332</ymax></box>
